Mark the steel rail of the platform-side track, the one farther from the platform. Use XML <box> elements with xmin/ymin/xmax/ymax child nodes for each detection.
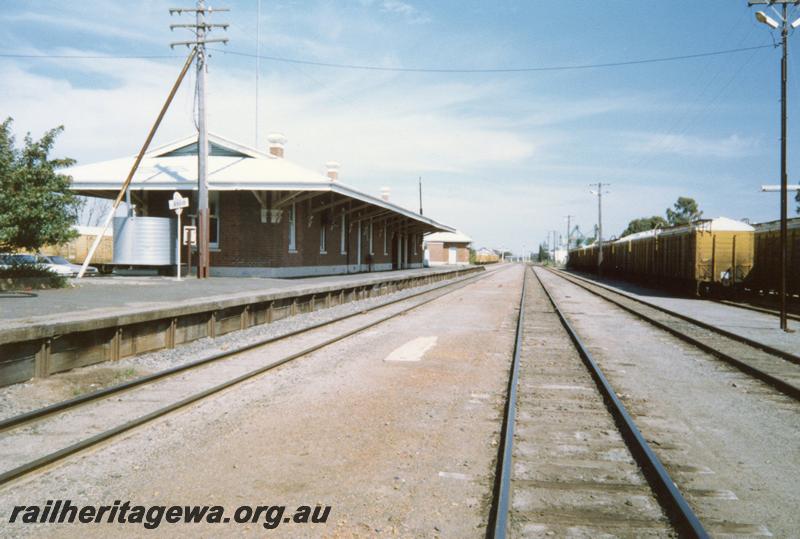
<box><xmin>0</xmin><ymin>272</ymin><xmax>496</xmax><ymax>485</ymax></box>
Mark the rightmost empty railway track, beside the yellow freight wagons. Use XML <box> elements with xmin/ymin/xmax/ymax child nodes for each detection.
<box><xmin>548</xmin><ymin>268</ymin><xmax>800</xmax><ymax>400</ymax></box>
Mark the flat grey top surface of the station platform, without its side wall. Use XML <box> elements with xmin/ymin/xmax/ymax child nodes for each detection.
<box><xmin>0</xmin><ymin>266</ymin><xmax>476</xmax><ymax>331</ymax></box>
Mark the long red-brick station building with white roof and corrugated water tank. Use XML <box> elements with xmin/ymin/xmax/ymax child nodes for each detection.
<box><xmin>65</xmin><ymin>135</ymin><xmax>454</xmax><ymax>277</ymax></box>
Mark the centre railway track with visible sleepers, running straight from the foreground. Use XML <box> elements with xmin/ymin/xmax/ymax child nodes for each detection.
<box><xmin>487</xmin><ymin>269</ymin><xmax>707</xmax><ymax>538</ymax></box>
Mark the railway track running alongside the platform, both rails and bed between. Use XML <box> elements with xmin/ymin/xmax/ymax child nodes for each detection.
<box><xmin>0</xmin><ymin>270</ymin><xmax>503</xmax><ymax>486</ymax></box>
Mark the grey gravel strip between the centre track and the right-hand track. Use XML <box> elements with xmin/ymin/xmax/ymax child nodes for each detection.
<box><xmin>538</xmin><ymin>270</ymin><xmax>800</xmax><ymax>537</ymax></box>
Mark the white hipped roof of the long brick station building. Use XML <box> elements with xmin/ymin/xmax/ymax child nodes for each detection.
<box><xmin>63</xmin><ymin>134</ymin><xmax>455</xmax><ymax>232</ymax></box>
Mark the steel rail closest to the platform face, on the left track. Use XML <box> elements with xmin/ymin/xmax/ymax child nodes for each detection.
<box><xmin>0</xmin><ymin>272</ymin><xmax>488</xmax><ymax>432</ymax></box>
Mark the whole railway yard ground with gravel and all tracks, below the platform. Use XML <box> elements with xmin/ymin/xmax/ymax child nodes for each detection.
<box><xmin>0</xmin><ymin>264</ymin><xmax>800</xmax><ymax>537</ymax></box>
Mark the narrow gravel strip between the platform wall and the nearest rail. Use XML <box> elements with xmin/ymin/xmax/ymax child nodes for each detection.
<box><xmin>0</xmin><ymin>270</ymin><xmax>488</xmax><ymax>418</ymax></box>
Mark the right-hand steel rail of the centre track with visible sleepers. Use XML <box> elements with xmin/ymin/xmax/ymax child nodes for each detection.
<box><xmin>531</xmin><ymin>269</ymin><xmax>708</xmax><ymax>538</ymax></box>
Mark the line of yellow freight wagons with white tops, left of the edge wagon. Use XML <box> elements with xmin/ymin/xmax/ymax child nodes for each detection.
<box><xmin>567</xmin><ymin>217</ymin><xmax>754</xmax><ymax>295</ymax></box>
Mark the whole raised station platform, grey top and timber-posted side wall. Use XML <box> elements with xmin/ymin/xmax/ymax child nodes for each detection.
<box><xmin>0</xmin><ymin>266</ymin><xmax>483</xmax><ymax>386</ymax></box>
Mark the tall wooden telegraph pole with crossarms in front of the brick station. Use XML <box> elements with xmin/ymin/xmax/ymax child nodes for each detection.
<box><xmin>169</xmin><ymin>0</ymin><xmax>230</xmax><ymax>279</ymax></box>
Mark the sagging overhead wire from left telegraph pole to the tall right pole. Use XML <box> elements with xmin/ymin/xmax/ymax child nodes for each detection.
<box><xmin>212</xmin><ymin>45</ymin><xmax>774</xmax><ymax>73</ymax></box>
